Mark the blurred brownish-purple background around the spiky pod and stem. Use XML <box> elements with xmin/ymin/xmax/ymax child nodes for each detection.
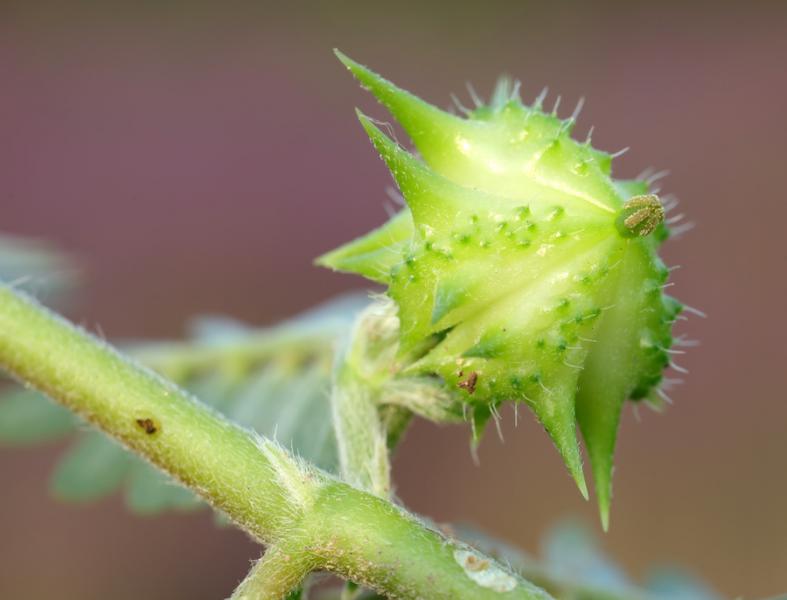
<box><xmin>0</xmin><ymin>1</ymin><xmax>787</xmax><ymax>599</ymax></box>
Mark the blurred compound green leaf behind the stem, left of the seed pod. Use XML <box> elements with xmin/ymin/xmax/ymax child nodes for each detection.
<box><xmin>0</xmin><ymin>294</ymin><xmax>368</xmax><ymax>514</ymax></box>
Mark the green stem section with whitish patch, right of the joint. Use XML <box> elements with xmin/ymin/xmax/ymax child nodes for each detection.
<box><xmin>307</xmin><ymin>483</ymin><xmax>550</xmax><ymax>600</ymax></box>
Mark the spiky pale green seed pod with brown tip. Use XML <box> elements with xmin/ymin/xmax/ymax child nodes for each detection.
<box><xmin>318</xmin><ymin>53</ymin><xmax>681</xmax><ymax>526</ymax></box>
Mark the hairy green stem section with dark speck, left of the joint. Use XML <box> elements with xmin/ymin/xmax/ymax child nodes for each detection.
<box><xmin>0</xmin><ymin>287</ymin><xmax>298</xmax><ymax>542</ymax></box>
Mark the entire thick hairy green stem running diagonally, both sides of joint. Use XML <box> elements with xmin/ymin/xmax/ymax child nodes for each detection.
<box><xmin>0</xmin><ymin>287</ymin><xmax>548</xmax><ymax>600</ymax></box>
